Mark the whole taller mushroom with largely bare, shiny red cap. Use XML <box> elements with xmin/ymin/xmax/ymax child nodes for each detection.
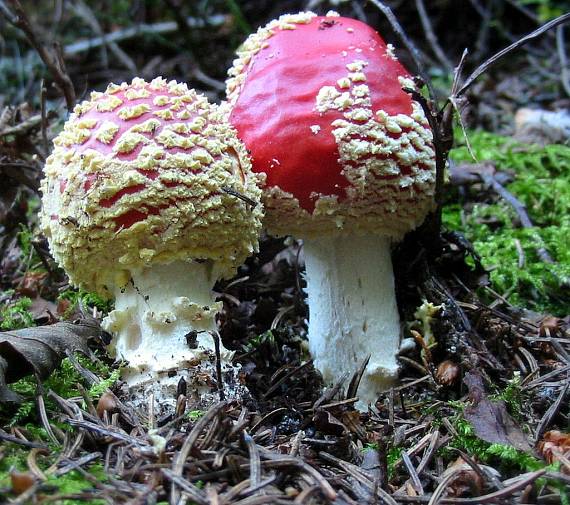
<box><xmin>227</xmin><ymin>12</ymin><xmax>435</xmax><ymax>408</ymax></box>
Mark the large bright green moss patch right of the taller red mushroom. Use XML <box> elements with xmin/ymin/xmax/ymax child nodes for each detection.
<box><xmin>443</xmin><ymin>132</ymin><xmax>570</xmax><ymax>315</ymax></box>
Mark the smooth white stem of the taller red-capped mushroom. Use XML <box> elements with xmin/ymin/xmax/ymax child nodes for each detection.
<box><xmin>303</xmin><ymin>235</ymin><xmax>400</xmax><ymax>410</ymax></box>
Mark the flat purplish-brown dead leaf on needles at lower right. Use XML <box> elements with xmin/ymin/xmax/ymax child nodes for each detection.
<box><xmin>463</xmin><ymin>372</ymin><xmax>531</xmax><ymax>452</ymax></box>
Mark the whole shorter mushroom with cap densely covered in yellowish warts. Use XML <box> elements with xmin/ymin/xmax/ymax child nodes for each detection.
<box><xmin>41</xmin><ymin>78</ymin><xmax>262</xmax><ymax>402</ymax></box>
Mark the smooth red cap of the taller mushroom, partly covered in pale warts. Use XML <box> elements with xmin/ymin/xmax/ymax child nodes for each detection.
<box><xmin>227</xmin><ymin>12</ymin><xmax>435</xmax><ymax>237</ymax></box>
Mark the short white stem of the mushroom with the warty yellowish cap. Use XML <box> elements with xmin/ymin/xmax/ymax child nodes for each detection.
<box><xmin>103</xmin><ymin>261</ymin><xmax>232</xmax><ymax>387</ymax></box>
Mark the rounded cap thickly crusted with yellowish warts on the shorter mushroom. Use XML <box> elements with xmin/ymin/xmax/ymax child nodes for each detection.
<box><xmin>41</xmin><ymin>78</ymin><xmax>262</xmax><ymax>295</ymax></box>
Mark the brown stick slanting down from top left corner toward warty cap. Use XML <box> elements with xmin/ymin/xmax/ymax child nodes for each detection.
<box><xmin>0</xmin><ymin>0</ymin><xmax>75</xmax><ymax>112</ymax></box>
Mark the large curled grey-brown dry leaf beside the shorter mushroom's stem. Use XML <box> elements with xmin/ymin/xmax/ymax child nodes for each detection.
<box><xmin>0</xmin><ymin>320</ymin><xmax>101</xmax><ymax>403</ymax></box>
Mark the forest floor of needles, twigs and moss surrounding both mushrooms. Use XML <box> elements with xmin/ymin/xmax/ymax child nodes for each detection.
<box><xmin>0</xmin><ymin>0</ymin><xmax>570</xmax><ymax>505</ymax></box>
